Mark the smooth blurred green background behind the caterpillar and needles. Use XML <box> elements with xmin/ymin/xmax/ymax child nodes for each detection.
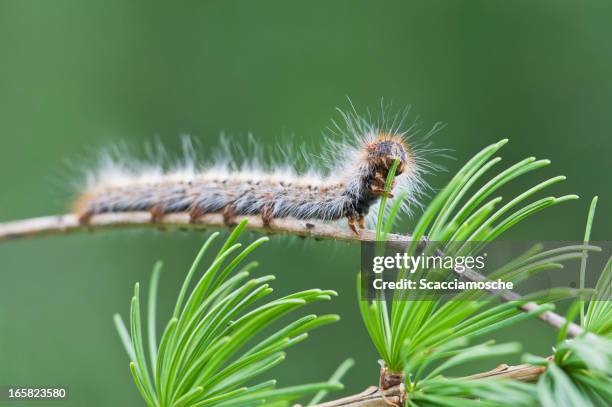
<box><xmin>0</xmin><ymin>0</ymin><xmax>612</xmax><ymax>406</ymax></box>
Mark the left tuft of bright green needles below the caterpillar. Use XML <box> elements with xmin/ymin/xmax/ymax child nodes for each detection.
<box><xmin>114</xmin><ymin>221</ymin><xmax>344</xmax><ymax>407</ymax></box>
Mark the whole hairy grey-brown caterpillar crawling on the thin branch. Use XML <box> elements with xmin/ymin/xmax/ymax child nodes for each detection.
<box><xmin>74</xmin><ymin>111</ymin><xmax>437</xmax><ymax>233</ymax></box>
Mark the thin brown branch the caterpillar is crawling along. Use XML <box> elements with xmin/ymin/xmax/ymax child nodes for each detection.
<box><xmin>0</xmin><ymin>212</ymin><xmax>583</xmax><ymax>338</ymax></box>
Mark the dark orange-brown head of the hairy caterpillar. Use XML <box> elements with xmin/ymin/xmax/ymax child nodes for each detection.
<box><xmin>366</xmin><ymin>133</ymin><xmax>410</xmax><ymax>178</ymax></box>
